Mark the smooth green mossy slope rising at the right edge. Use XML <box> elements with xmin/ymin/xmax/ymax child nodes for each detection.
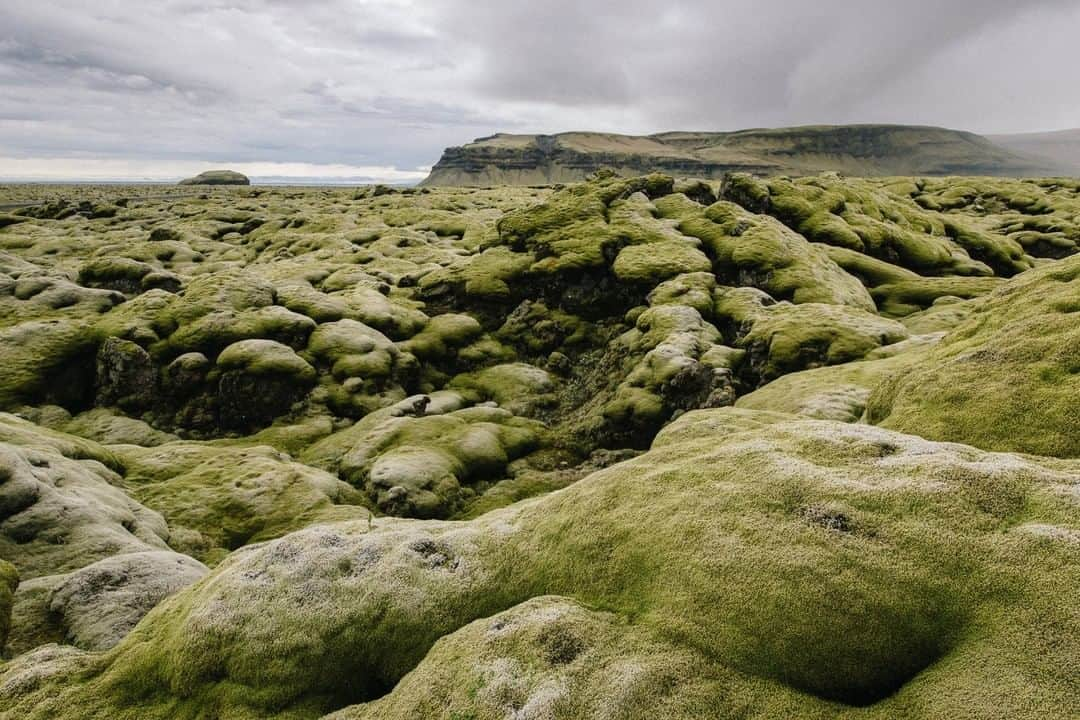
<box><xmin>869</xmin><ymin>253</ymin><xmax>1080</xmax><ymax>457</ymax></box>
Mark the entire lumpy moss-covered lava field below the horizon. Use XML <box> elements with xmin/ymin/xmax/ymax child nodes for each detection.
<box><xmin>0</xmin><ymin>173</ymin><xmax>1080</xmax><ymax>720</ymax></box>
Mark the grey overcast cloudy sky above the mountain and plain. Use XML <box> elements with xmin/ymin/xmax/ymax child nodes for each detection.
<box><xmin>0</xmin><ymin>0</ymin><xmax>1080</xmax><ymax>181</ymax></box>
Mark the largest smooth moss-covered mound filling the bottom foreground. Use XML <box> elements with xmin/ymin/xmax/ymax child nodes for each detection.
<box><xmin>0</xmin><ymin>410</ymin><xmax>1080</xmax><ymax>718</ymax></box>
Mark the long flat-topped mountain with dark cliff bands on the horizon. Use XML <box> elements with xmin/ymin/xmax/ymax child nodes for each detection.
<box><xmin>422</xmin><ymin>125</ymin><xmax>1059</xmax><ymax>186</ymax></box>
